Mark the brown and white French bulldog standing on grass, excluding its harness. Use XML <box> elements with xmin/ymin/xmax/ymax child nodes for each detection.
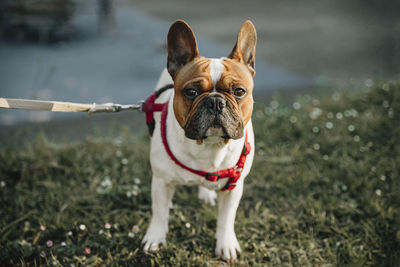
<box><xmin>142</xmin><ymin>20</ymin><xmax>257</xmax><ymax>260</ymax></box>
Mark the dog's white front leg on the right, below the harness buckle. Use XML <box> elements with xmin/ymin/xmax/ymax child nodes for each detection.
<box><xmin>215</xmin><ymin>179</ymin><xmax>243</xmax><ymax>260</ymax></box>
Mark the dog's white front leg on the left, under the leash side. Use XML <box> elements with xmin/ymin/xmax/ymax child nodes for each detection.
<box><xmin>142</xmin><ymin>176</ymin><xmax>175</xmax><ymax>251</ymax></box>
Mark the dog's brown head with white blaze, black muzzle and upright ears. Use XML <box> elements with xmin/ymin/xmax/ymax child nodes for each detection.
<box><xmin>167</xmin><ymin>20</ymin><xmax>257</xmax><ymax>140</ymax></box>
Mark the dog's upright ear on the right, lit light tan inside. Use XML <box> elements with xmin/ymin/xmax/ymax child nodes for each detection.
<box><xmin>228</xmin><ymin>20</ymin><xmax>257</xmax><ymax>76</ymax></box>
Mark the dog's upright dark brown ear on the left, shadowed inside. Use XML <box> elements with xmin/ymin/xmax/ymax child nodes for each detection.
<box><xmin>167</xmin><ymin>20</ymin><xmax>199</xmax><ymax>78</ymax></box>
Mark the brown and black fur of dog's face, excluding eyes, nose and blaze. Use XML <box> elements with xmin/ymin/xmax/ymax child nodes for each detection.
<box><xmin>173</xmin><ymin>57</ymin><xmax>253</xmax><ymax>140</ymax></box>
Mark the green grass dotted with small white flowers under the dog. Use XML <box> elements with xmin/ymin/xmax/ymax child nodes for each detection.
<box><xmin>0</xmin><ymin>82</ymin><xmax>400</xmax><ymax>266</ymax></box>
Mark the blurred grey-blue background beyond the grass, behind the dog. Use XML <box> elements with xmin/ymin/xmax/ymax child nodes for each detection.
<box><xmin>0</xmin><ymin>0</ymin><xmax>400</xmax><ymax>138</ymax></box>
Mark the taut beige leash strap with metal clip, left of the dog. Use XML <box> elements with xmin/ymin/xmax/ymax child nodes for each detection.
<box><xmin>0</xmin><ymin>98</ymin><xmax>142</xmax><ymax>114</ymax></box>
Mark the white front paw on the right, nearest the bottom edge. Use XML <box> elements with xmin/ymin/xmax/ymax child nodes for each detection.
<box><xmin>215</xmin><ymin>233</ymin><xmax>241</xmax><ymax>262</ymax></box>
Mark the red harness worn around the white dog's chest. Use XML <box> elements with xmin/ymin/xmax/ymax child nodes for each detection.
<box><xmin>142</xmin><ymin>85</ymin><xmax>251</xmax><ymax>191</ymax></box>
